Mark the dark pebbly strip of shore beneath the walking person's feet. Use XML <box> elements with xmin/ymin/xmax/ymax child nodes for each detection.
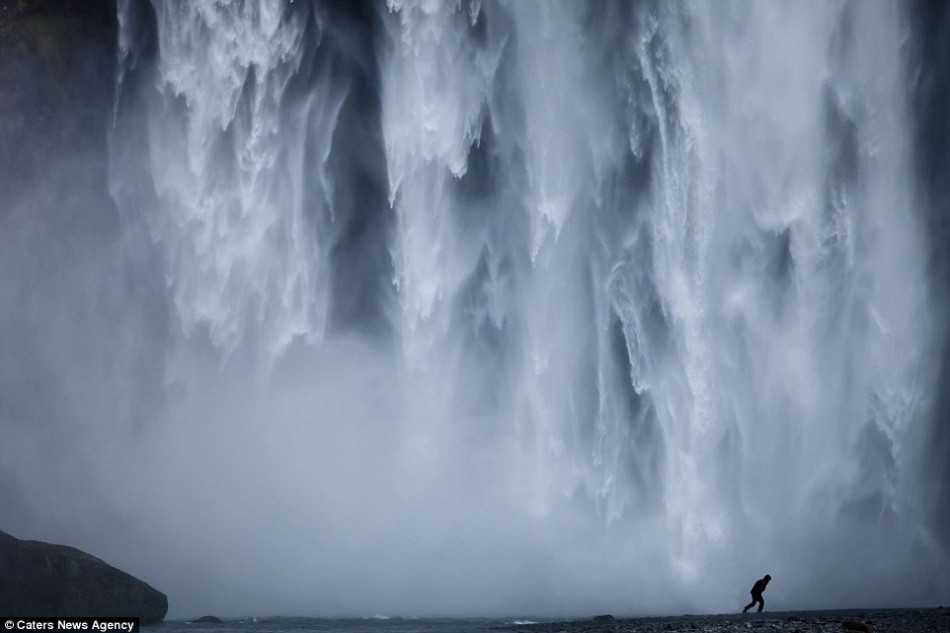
<box><xmin>506</xmin><ymin>607</ymin><xmax>950</xmax><ymax>633</ymax></box>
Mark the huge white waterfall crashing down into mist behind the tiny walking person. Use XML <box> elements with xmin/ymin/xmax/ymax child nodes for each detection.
<box><xmin>1</xmin><ymin>0</ymin><xmax>950</xmax><ymax>615</ymax></box>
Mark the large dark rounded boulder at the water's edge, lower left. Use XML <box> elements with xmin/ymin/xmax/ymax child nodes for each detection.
<box><xmin>0</xmin><ymin>532</ymin><xmax>168</xmax><ymax>624</ymax></box>
